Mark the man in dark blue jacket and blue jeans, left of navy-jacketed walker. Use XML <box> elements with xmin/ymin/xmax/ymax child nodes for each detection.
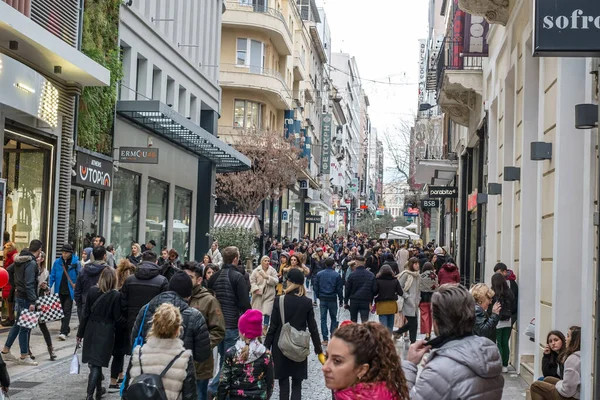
<box><xmin>313</xmin><ymin>258</ymin><xmax>344</xmax><ymax>346</ymax></box>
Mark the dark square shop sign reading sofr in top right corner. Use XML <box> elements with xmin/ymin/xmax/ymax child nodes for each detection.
<box><xmin>533</xmin><ymin>0</ymin><xmax>600</xmax><ymax>57</ymax></box>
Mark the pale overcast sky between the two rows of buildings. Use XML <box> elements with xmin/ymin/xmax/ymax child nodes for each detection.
<box><xmin>317</xmin><ymin>0</ymin><xmax>429</xmax><ymax>181</ymax></box>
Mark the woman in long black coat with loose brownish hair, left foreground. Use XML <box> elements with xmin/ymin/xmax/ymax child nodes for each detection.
<box><xmin>77</xmin><ymin>267</ymin><xmax>122</xmax><ymax>400</ymax></box>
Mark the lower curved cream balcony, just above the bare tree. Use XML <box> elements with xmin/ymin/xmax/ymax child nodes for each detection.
<box><xmin>219</xmin><ymin>64</ymin><xmax>292</xmax><ymax>110</ymax></box>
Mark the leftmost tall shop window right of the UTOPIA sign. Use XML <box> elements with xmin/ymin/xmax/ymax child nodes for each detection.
<box><xmin>111</xmin><ymin>168</ymin><xmax>140</xmax><ymax>260</ymax></box>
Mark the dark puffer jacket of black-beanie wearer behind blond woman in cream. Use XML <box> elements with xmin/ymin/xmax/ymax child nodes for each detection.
<box><xmin>131</xmin><ymin>291</ymin><xmax>211</xmax><ymax>362</ymax></box>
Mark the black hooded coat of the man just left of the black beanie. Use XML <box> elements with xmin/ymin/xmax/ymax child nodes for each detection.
<box><xmin>121</xmin><ymin>261</ymin><xmax>169</xmax><ymax>354</ymax></box>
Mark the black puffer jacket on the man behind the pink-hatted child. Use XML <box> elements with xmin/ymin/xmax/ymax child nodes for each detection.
<box><xmin>208</xmin><ymin>264</ymin><xmax>251</xmax><ymax>329</ymax></box>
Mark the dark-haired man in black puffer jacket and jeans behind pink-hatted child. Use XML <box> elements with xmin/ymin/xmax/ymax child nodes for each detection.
<box><xmin>208</xmin><ymin>246</ymin><xmax>252</xmax><ymax>394</ymax></box>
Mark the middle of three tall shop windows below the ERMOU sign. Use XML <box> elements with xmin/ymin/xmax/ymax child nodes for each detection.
<box><xmin>146</xmin><ymin>178</ymin><xmax>169</xmax><ymax>249</ymax></box>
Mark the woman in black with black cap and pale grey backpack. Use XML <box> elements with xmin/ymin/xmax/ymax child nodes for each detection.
<box><xmin>265</xmin><ymin>268</ymin><xmax>323</xmax><ymax>400</ymax></box>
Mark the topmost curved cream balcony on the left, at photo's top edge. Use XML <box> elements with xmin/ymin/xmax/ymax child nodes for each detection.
<box><xmin>222</xmin><ymin>0</ymin><xmax>294</xmax><ymax>56</ymax></box>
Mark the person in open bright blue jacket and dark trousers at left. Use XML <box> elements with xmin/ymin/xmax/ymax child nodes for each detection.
<box><xmin>48</xmin><ymin>243</ymin><xmax>81</xmax><ymax>341</ymax></box>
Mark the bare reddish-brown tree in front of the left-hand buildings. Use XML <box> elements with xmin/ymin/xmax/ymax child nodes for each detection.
<box><xmin>216</xmin><ymin>130</ymin><xmax>307</xmax><ymax>214</ymax></box>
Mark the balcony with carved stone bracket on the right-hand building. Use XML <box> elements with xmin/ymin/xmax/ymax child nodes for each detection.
<box><xmin>436</xmin><ymin>38</ymin><xmax>483</xmax><ymax>127</ymax></box>
